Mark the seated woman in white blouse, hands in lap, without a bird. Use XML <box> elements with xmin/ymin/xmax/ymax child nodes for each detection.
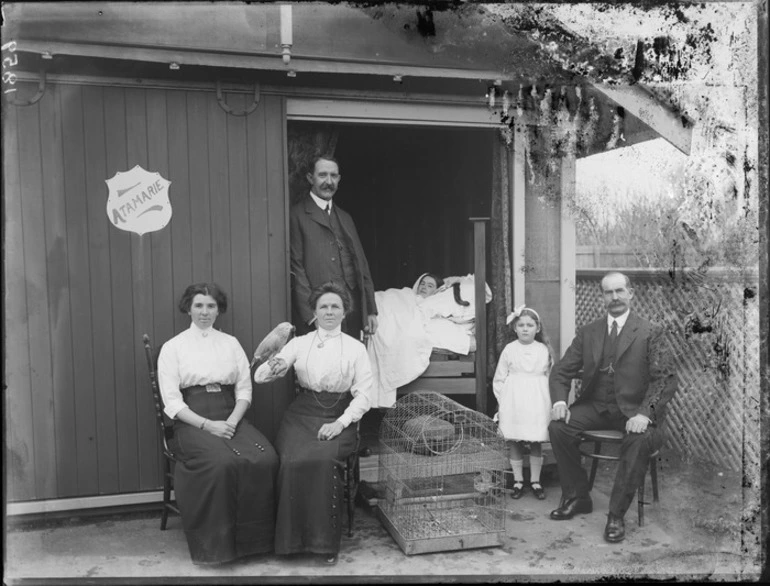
<box><xmin>158</xmin><ymin>283</ymin><xmax>278</xmax><ymax>564</ymax></box>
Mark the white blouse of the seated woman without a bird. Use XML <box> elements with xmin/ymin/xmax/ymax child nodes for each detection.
<box><xmin>158</xmin><ymin>323</ymin><xmax>251</xmax><ymax>419</ymax></box>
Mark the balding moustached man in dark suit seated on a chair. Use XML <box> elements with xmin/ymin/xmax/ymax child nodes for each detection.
<box><xmin>549</xmin><ymin>272</ymin><xmax>677</xmax><ymax>543</ymax></box>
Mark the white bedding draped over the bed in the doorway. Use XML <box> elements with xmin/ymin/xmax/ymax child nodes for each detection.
<box><xmin>368</xmin><ymin>275</ymin><xmax>492</xmax><ymax>407</ymax></box>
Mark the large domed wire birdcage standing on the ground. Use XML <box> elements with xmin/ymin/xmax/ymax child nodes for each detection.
<box><xmin>379</xmin><ymin>391</ymin><xmax>508</xmax><ymax>555</ymax></box>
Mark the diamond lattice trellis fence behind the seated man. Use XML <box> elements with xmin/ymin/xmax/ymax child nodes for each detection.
<box><xmin>575</xmin><ymin>271</ymin><xmax>759</xmax><ymax>470</ymax></box>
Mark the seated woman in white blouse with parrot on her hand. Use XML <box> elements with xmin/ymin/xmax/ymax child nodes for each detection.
<box><xmin>255</xmin><ymin>283</ymin><xmax>372</xmax><ymax>564</ymax></box>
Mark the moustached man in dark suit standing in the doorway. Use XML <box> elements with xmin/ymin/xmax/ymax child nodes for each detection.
<box><xmin>290</xmin><ymin>155</ymin><xmax>377</xmax><ymax>340</ymax></box>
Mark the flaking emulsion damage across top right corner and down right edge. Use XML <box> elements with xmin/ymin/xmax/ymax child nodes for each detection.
<box><xmin>352</xmin><ymin>3</ymin><xmax>760</xmax><ymax>571</ymax></box>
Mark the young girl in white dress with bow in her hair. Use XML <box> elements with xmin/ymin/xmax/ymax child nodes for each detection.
<box><xmin>492</xmin><ymin>305</ymin><xmax>553</xmax><ymax>500</ymax></box>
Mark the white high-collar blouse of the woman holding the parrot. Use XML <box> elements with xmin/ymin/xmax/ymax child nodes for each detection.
<box><xmin>276</xmin><ymin>327</ymin><xmax>372</xmax><ymax>427</ymax></box>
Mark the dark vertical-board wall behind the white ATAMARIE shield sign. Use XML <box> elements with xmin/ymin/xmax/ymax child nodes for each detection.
<box><xmin>3</xmin><ymin>83</ymin><xmax>290</xmax><ymax>502</ymax></box>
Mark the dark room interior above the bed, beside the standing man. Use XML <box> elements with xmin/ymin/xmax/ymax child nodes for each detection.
<box><xmin>290</xmin><ymin>122</ymin><xmax>494</xmax><ymax>290</ymax></box>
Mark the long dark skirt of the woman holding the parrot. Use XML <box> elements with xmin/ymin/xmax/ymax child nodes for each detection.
<box><xmin>275</xmin><ymin>392</ymin><xmax>356</xmax><ymax>554</ymax></box>
